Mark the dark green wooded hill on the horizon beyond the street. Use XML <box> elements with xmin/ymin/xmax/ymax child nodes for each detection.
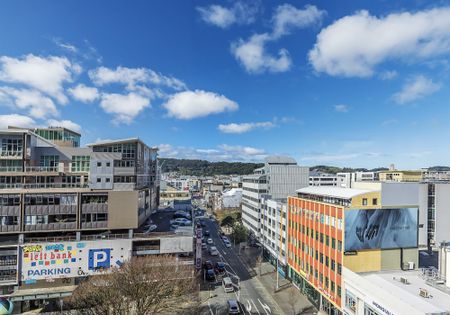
<box><xmin>159</xmin><ymin>158</ymin><xmax>264</xmax><ymax>176</ymax></box>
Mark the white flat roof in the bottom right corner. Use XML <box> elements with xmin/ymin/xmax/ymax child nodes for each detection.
<box><xmin>358</xmin><ymin>270</ymin><xmax>450</xmax><ymax>314</ymax></box>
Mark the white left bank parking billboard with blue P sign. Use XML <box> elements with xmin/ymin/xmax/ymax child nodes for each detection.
<box><xmin>20</xmin><ymin>239</ymin><xmax>131</xmax><ymax>283</ymax></box>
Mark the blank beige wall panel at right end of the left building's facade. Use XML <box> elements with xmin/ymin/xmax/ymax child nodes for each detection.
<box><xmin>108</xmin><ymin>191</ymin><xmax>138</xmax><ymax>229</ymax></box>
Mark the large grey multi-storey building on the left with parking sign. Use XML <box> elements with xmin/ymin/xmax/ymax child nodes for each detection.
<box><xmin>0</xmin><ymin>128</ymin><xmax>188</xmax><ymax>312</ymax></box>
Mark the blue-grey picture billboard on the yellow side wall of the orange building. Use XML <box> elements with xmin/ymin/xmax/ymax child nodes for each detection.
<box><xmin>344</xmin><ymin>208</ymin><xmax>418</xmax><ymax>251</ymax></box>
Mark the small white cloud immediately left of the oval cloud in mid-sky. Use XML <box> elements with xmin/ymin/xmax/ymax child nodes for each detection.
<box><xmin>100</xmin><ymin>93</ymin><xmax>150</xmax><ymax>124</ymax></box>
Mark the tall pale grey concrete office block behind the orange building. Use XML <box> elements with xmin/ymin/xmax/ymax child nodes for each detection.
<box><xmin>242</xmin><ymin>156</ymin><xmax>309</xmax><ymax>238</ymax></box>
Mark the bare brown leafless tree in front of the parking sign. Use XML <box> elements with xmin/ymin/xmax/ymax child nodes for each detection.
<box><xmin>68</xmin><ymin>255</ymin><xmax>198</xmax><ymax>315</ymax></box>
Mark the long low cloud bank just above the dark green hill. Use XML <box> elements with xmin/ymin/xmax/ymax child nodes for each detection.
<box><xmin>158</xmin><ymin>144</ymin><xmax>267</xmax><ymax>162</ymax></box>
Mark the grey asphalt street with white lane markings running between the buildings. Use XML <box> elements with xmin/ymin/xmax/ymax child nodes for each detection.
<box><xmin>203</xmin><ymin>219</ymin><xmax>284</xmax><ymax>315</ymax></box>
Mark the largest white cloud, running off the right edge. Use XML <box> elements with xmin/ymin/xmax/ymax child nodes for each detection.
<box><xmin>309</xmin><ymin>7</ymin><xmax>450</xmax><ymax>77</ymax></box>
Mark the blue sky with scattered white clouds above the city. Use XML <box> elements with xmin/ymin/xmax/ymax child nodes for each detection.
<box><xmin>0</xmin><ymin>0</ymin><xmax>450</xmax><ymax>169</ymax></box>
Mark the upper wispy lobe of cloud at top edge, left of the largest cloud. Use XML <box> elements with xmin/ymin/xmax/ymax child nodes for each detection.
<box><xmin>272</xmin><ymin>4</ymin><xmax>326</xmax><ymax>38</ymax></box>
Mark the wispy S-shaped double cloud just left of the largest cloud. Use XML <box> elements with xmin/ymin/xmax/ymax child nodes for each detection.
<box><xmin>231</xmin><ymin>4</ymin><xmax>325</xmax><ymax>74</ymax></box>
